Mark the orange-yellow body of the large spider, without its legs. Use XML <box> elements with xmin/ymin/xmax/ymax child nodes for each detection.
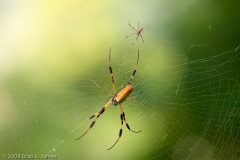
<box><xmin>112</xmin><ymin>85</ymin><xmax>133</xmax><ymax>106</ymax></box>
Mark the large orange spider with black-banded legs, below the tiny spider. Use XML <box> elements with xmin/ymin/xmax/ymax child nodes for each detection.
<box><xmin>76</xmin><ymin>48</ymin><xmax>141</xmax><ymax>150</ymax></box>
